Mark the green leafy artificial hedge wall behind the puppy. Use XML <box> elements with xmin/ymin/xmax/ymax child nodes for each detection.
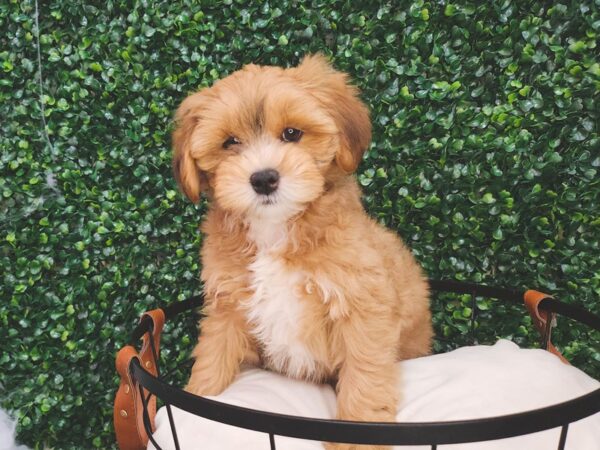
<box><xmin>0</xmin><ymin>0</ymin><xmax>600</xmax><ymax>449</ymax></box>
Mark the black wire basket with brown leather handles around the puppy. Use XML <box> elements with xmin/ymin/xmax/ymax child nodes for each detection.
<box><xmin>114</xmin><ymin>280</ymin><xmax>600</xmax><ymax>450</ymax></box>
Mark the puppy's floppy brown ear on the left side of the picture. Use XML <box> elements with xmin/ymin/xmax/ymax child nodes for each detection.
<box><xmin>173</xmin><ymin>92</ymin><xmax>208</xmax><ymax>203</ymax></box>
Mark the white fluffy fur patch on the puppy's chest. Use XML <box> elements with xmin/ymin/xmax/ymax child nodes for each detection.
<box><xmin>246</xmin><ymin>221</ymin><xmax>316</xmax><ymax>378</ymax></box>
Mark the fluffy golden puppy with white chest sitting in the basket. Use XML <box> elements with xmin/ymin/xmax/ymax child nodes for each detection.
<box><xmin>173</xmin><ymin>55</ymin><xmax>432</xmax><ymax>448</ymax></box>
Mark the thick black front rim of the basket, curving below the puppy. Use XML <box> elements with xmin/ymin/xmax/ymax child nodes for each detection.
<box><xmin>130</xmin><ymin>358</ymin><xmax>600</xmax><ymax>445</ymax></box>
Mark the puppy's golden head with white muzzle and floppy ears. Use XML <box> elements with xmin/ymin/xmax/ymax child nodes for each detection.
<box><xmin>173</xmin><ymin>55</ymin><xmax>371</xmax><ymax>220</ymax></box>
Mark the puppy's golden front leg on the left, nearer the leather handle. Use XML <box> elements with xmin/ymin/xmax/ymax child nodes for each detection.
<box><xmin>185</xmin><ymin>310</ymin><xmax>258</xmax><ymax>395</ymax></box>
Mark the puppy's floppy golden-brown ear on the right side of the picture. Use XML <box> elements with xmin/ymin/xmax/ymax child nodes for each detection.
<box><xmin>293</xmin><ymin>54</ymin><xmax>371</xmax><ymax>173</ymax></box>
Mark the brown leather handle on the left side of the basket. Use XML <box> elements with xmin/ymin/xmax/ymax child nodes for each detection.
<box><xmin>113</xmin><ymin>309</ymin><xmax>165</xmax><ymax>450</ymax></box>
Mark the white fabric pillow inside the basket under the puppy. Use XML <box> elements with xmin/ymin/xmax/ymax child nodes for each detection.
<box><xmin>148</xmin><ymin>340</ymin><xmax>600</xmax><ymax>450</ymax></box>
